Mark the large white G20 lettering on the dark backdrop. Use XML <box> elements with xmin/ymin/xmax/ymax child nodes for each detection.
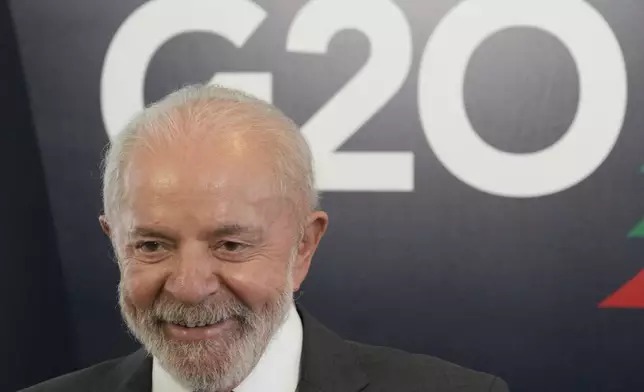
<box><xmin>101</xmin><ymin>0</ymin><xmax>627</xmax><ymax>198</ymax></box>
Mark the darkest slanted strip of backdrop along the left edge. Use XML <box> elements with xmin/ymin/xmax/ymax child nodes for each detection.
<box><xmin>0</xmin><ymin>2</ymin><xmax>76</xmax><ymax>391</ymax></box>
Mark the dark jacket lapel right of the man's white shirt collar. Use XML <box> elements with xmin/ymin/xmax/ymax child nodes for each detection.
<box><xmin>297</xmin><ymin>307</ymin><xmax>369</xmax><ymax>392</ymax></box>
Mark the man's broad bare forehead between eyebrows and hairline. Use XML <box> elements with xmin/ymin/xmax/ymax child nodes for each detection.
<box><xmin>124</xmin><ymin>129</ymin><xmax>288</xmax><ymax>227</ymax></box>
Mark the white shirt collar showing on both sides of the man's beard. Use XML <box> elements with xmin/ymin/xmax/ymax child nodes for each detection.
<box><xmin>152</xmin><ymin>306</ymin><xmax>302</xmax><ymax>392</ymax></box>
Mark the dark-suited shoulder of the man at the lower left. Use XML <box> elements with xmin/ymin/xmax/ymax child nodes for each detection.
<box><xmin>19</xmin><ymin>358</ymin><xmax>128</xmax><ymax>392</ymax></box>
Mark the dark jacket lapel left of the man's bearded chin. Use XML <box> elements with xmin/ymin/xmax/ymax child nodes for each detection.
<box><xmin>96</xmin><ymin>349</ymin><xmax>152</xmax><ymax>392</ymax></box>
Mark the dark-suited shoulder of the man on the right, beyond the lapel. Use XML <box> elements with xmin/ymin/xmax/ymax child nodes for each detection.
<box><xmin>347</xmin><ymin>342</ymin><xmax>508</xmax><ymax>392</ymax></box>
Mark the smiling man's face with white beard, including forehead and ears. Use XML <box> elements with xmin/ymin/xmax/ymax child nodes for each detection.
<box><xmin>103</xmin><ymin>130</ymin><xmax>327</xmax><ymax>389</ymax></box>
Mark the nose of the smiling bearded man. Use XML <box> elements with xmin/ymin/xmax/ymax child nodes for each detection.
<box><xmin>164</xmin><ymin>243</ymin><xmax>221</xmax><ymax>305</ymax></box>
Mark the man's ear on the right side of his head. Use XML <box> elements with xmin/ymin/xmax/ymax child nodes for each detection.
<box><xmin>291</xmin><ymin>211</ymin><xmax>329</xmax><ymax>291</ymax></box>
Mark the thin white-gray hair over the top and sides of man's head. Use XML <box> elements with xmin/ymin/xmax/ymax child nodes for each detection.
<box><xmin>103</xmin><ymin>85</ymin><xmax>318</xmax><ymax>227</ymax></box>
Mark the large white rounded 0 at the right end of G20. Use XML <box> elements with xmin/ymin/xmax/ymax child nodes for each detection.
<box><xmin>418</xmin><ymin>0</ymin><xmax>627</xmax><ymax>197</ymax></box>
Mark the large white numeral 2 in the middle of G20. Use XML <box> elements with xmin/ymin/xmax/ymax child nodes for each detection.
<box><xmin>286</xmin><ymin>0</ymin><xmax>414</xmax><ymax>191</ymax></box>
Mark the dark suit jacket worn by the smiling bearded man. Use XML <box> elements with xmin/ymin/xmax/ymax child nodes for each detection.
<box><xmin>23</xmin><ymin>309</ymin><xmax>508</xmax><ymax>392</ymax></box>
